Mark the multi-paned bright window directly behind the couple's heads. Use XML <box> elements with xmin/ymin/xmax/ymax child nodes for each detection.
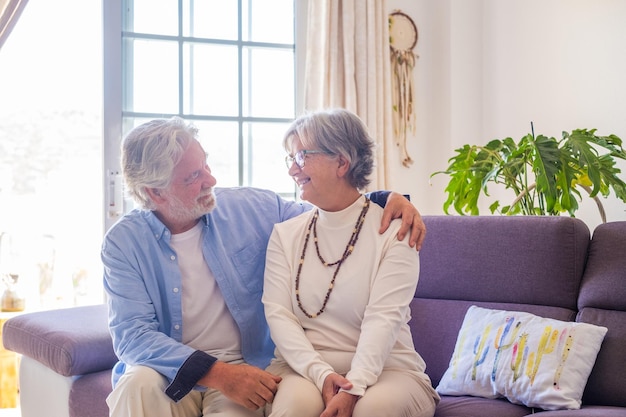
<box><xmin>105</xmin><ymin>0</ymin><xmax>296</xmax><ymax>228</ymax></box>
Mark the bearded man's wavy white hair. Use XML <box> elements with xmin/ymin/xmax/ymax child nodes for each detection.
<box><xmin>122</xmin><ymin>117</ymin><xmax>198</xmax><ymax>210</ymax></box>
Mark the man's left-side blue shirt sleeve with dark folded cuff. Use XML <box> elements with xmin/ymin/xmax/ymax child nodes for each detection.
<box><xmin>101</xmin><ymin>210</ymin><xmax>215</xmax><ymax>401</ymax></box>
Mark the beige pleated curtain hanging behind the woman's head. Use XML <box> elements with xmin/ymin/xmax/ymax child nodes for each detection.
<box><xmin>305</xmin><ymin>0</ymin><xmax>393</xmax><ymax>190</ymax></box>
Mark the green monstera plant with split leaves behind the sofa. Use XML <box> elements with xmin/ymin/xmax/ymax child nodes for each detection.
<box><xmin>431</xmin><ymin>124</ymin><xmax>626</xmax><ymax>221</ymax></box>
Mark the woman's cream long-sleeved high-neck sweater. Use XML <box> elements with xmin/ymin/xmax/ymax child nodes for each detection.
<box><xmin>263</xmin><ymin>193</ymin><xmax>425</xmax><ymax>395</ymax></box>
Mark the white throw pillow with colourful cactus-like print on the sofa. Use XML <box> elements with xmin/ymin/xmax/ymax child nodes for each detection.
<box><xmin>437</xmin><ymin>306</ymin><xmax>607</xmax><ymax>410</ymax></box>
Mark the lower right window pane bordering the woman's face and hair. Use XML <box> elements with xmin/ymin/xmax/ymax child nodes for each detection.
<box><xmin>244</xmin><ymin>123</ymin><xmax>294</xmax><ymax>194</ymax></box>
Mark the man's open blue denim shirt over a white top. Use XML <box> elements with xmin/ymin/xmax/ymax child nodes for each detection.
<box><xmin>101</xmin><ymin>188</ymin><xmax>387</xmax><ymax>401</ymax></box>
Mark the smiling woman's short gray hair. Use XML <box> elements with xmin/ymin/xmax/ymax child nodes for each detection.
<box><xmin>283</xmin><ymin>109</ymin><xmax>375</xmax><ymax>190</ymax></box>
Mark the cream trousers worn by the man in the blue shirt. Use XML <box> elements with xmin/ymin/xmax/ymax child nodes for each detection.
<box><xmin>107</xmin><ymin>366</ymin><xmax>264</xmax><ymax>417</ymax></box>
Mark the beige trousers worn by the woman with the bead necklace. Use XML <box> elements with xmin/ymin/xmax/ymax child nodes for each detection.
<box><xmin>266</xmin><ymin>361</ymin><xmax>439</xmax><ymax>417</ymax></box>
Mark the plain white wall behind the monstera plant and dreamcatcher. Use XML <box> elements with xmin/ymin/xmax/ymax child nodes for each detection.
<box><xmin>387</xmin><ymin>0</ymin><xmax>626</xmax><ymax>229</ymax></box>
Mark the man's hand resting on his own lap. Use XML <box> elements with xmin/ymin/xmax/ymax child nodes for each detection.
<box><xmin>198</xmin><ymin>361</ymin><xmax>282</xmax><ymax>410</ymax></box>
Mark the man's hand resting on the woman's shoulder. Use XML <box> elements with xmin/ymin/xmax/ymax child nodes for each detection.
<box><xmin>379</xmin><ymin>191</ymin><xmax>426</xmax><ymax>250</ymax></box>
